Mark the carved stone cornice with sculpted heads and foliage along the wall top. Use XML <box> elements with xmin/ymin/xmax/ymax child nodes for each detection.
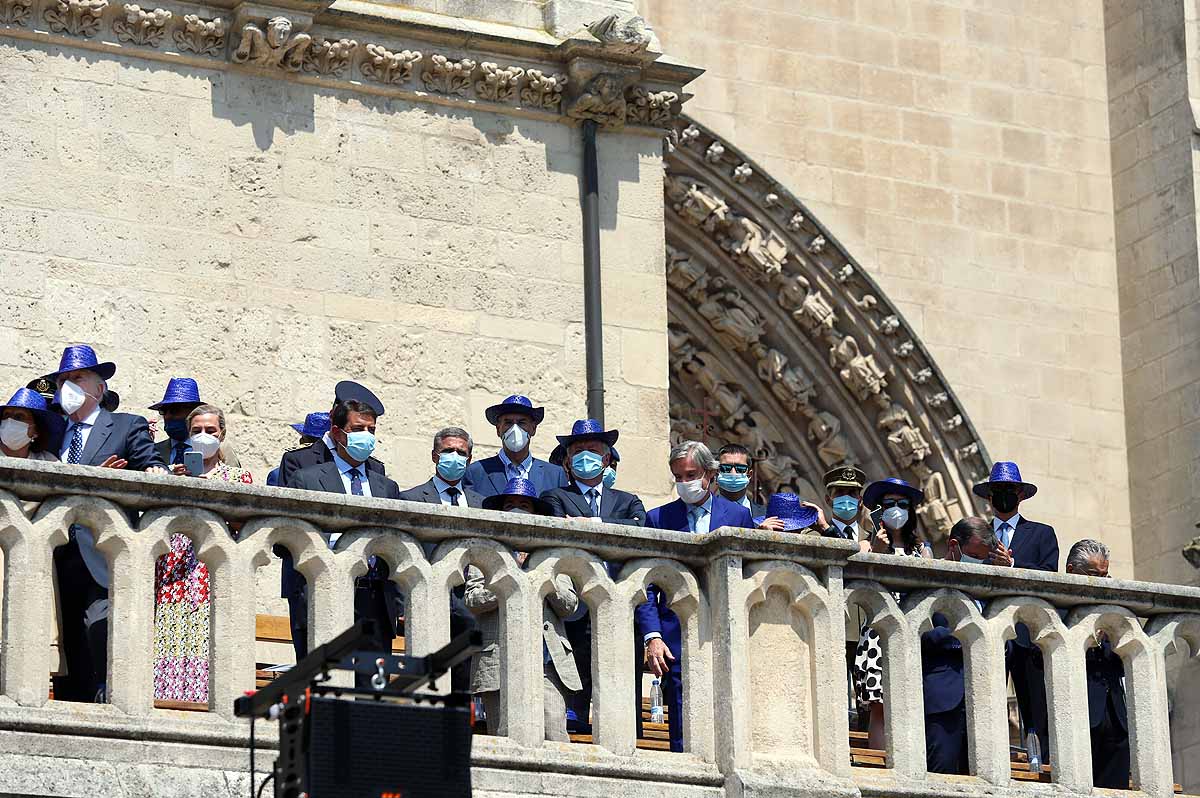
<box><xmin>0</xmin><ymin>0</ymin><xmax>701</xmax><ymax>136</ymax></box>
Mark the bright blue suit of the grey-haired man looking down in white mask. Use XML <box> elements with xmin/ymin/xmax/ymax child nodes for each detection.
<box><xmin>634</xmin><ymin>496</ymin><xmax>754</xmax><ymax>751</ymax></box>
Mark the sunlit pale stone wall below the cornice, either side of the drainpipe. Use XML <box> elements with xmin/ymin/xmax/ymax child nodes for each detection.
<box><xmin>0</xmin><ymin>40</ymin><xmax>668</xmax><ymax>494</ymax></box>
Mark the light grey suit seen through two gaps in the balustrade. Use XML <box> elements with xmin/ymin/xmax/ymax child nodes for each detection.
<box><xmin>466</xmin><ymin>565</ymin><xmax>583</xmax><ymax>743</ymax></box>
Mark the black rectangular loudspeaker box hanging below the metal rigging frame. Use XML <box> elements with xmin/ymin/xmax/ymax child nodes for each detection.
<box><xmin>305</xmin><ymin>696</ymin><xmax>470</xmax><ymax>798</ymax></box>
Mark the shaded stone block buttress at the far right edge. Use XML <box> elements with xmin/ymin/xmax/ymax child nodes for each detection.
<box><xmin>1105</xmin><ymin>0</ymin><xmax>1200</xmax><ymax>787</ymax></box>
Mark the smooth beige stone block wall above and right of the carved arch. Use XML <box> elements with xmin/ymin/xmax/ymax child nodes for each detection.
<box><xmin>640</xmin><ymin>0</ymin><xmax>1133</xmax><ymax>576</ymax></box>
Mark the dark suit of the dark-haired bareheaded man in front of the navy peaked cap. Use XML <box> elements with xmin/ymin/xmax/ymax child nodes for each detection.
<box><xmin>288</xmin><ymin>458</ymin><xmax>400</xmax><ymax>658</ymax></box>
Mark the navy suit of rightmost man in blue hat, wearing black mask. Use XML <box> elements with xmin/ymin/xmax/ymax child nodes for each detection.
<box><xmin>1006</xmin><ymin>516</ymin><xmax>1058</xmax><ymax>762</ymax></box>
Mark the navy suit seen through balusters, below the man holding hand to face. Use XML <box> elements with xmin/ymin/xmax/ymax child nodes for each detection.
<box><xmin>920</xmin><ymin>612</ymin><xmax>967</xmax><ymax>775</ymax></box>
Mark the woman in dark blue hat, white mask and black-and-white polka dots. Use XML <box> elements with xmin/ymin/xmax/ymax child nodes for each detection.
<box><xmin>854</xmin><ymin>476</ymin><xmax>934</xmax><ymax>749</ymax></box>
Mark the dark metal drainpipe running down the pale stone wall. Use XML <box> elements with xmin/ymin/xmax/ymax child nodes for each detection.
<box><xmin>583</xmin><ymin>119</ymin><xmax>604</xmax><ymax>424</ymax></box>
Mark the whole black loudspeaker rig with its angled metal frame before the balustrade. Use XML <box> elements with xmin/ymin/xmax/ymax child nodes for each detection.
<box><xmin>234</xmin><ymin>619</ymin><xmax>482</xmax><ymax>798</ymax></box>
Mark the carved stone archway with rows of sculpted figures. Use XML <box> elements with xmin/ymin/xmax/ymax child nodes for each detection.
<box><xmin>666</xmin><ymin>118</ymin><xmax>990</xmax><ymax>540</ymax></box>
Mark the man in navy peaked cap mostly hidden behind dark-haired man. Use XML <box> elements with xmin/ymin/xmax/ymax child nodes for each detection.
<box><xmin>282</xmin><ymin>379</ymin><xmax>384</xmax><ymax>661</ymax></box>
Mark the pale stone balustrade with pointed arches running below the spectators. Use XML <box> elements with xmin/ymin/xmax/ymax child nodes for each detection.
<box><xmin>0</xmin><ymin>458</ymin><xmax>1200</xmax><ymax>796</ymax></box>
